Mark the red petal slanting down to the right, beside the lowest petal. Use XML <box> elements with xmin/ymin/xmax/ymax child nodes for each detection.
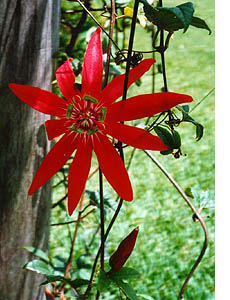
<box><xmin>92</xmin><ymin>133</ymin><xmax>133</xmax><ymax>201</ymax></box>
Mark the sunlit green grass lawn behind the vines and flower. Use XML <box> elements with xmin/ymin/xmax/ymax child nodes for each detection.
<box><xmin>50</xmin><ymin>0</ymin><xmax>214</xmax><ymax>300</ymax></box>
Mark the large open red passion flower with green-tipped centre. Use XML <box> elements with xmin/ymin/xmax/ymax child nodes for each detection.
<box><xmin>9</xmin><ymin>28</ymin><xmax>192</xmax><ymax>215</ymax></box>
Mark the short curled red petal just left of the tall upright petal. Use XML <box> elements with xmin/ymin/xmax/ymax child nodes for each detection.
<box><xmin>56</xmin><ymin>58</ymin><xmax>80</xmax><ymax>102</ymax></box>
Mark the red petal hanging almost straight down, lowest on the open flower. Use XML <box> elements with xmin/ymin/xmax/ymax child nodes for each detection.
<box><xmin>68</xmin><ymin>135</ymin><xmax>92</xmax><ymax>216</ymax></box>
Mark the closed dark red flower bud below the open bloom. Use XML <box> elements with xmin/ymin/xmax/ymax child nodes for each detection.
<box><xmin>109</xmin><ymin>227</ymin><xmax>139</xmax><ymax>271</ymax></box>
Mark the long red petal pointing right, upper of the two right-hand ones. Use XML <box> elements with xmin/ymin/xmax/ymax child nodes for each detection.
<box><xmin>106</xmin><ymin>92</ymin><xmax>193</xmax><ymax>121</ymax></box>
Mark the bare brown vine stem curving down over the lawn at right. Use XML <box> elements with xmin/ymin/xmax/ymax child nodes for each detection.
<box><xmin>144</xmin><ymin>150</ymin><xmax>208</xmax><ymax>300</ymax></box>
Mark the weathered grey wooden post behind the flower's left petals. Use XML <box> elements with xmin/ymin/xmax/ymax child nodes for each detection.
<box><xmin>0</xmin><ymin>0</ymin><xmax>60</xmax><ymax>300</ymax></box>
